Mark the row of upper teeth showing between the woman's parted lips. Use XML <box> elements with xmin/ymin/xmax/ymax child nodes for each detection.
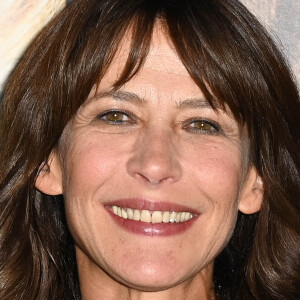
<box><xmin>112</xmin><ymin>205</ymin><xmax>194</xmax><ymax>223</ymax></box>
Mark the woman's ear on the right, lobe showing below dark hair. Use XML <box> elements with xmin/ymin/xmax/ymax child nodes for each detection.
<box><xmin>239</xmin><ymin>166</ymin><xmax>264</xmax><ymax>214</ymax></box>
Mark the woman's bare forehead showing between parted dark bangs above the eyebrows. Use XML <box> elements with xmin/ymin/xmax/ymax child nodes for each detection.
<box><xmin>89</xmin><ymin>23</ymin><xmax>227</xmax><ymax>110</ymax></box>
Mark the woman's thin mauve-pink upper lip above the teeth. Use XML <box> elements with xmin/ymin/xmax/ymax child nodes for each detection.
<box><xmin>104</xmin><ymin>198</ymin><xmax>199</xmax><ymax>214</ymax></box>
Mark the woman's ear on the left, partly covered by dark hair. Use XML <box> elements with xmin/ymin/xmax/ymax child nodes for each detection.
<box><xmin>35</xmin><ymin>152</ymin><xmax>63</xmax><ymax>196</ymax></box>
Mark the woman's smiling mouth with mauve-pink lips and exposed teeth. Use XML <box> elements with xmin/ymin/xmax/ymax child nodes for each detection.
<box><xmin>104</xmin><ymin>198</ymin><xmax>201</xmax><ymax>237</ymax></box>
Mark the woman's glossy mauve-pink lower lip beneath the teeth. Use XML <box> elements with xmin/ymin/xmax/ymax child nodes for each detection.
<box><xmin>107</xmin><ymin>208</ymin><xmax>198</xmax><ymax>237</ymax></box>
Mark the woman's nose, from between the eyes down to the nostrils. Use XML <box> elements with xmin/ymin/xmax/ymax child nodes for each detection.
<box><xmin>127</xmin><ymin>130</ymin><xmax>182</xmax><ymax>185</ymax></box>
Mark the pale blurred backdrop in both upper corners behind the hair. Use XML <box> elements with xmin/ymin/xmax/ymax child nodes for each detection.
<box><xmin>0</xmin><ymin>0</ymin><xmax>300</xmax><ymax>92</ymax></box>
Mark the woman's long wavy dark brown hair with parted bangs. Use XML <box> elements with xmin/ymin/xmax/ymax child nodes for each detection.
<box><xmin>0</xmin><ymin>0</ymin><xmax>300</xmax><ymax>300</ymax></box>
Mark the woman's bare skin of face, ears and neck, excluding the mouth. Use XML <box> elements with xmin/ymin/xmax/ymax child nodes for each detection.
<box><xmin>36</xmin><ymin>26</ymin><xmax>262</xmax><ymax>300</ymax></box>
